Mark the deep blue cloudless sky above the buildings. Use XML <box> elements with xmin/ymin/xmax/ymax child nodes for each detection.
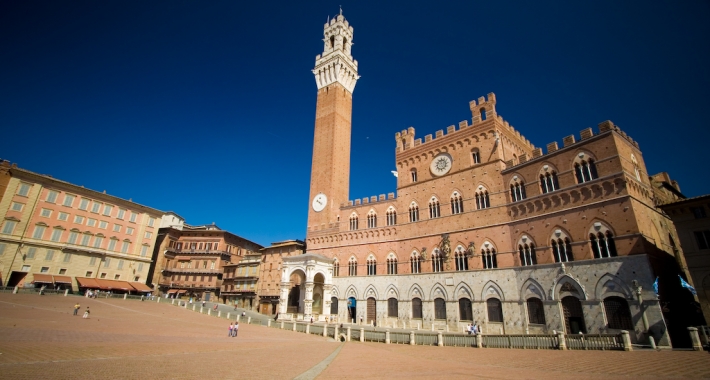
<box><xmin>0</xmin><ymin>0</ymin><xmax>710</xmax><ymax>245</ymax></box>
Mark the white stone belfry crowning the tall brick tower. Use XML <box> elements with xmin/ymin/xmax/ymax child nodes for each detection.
<box><xmin>313</xmin><ymin>14</ymin><xmax>360</xmax><ymax>93</ymax></box>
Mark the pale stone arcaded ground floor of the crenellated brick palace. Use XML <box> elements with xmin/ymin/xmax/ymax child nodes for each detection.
<box><xmin>332</xmin><ymin>255</ymin><xmax>670</xmax><ymax>346</ymax></box>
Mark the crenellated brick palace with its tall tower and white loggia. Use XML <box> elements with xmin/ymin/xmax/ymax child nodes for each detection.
<box><xmin>280</xmin><ymin>15</ymin><xmax>700</xmax><ymax>345</ymax></box>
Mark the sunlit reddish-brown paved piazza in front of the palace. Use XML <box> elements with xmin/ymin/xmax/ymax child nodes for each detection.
<box><xmin>0</xmin><ymin>293</ymin><xmax>710</xmax><ymax>379</ymax></box>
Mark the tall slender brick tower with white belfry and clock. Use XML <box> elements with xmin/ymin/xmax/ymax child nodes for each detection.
<box><xmin>307</xmin><ymin>11</ymin><xmax>359</xmax><ymax>235</ymax></box>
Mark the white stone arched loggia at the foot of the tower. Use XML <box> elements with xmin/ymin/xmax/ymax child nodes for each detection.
<box><xmin>279</xmin><ymin>253</ymin><xmax>333</xmax><ymax>321</ymax></box>
